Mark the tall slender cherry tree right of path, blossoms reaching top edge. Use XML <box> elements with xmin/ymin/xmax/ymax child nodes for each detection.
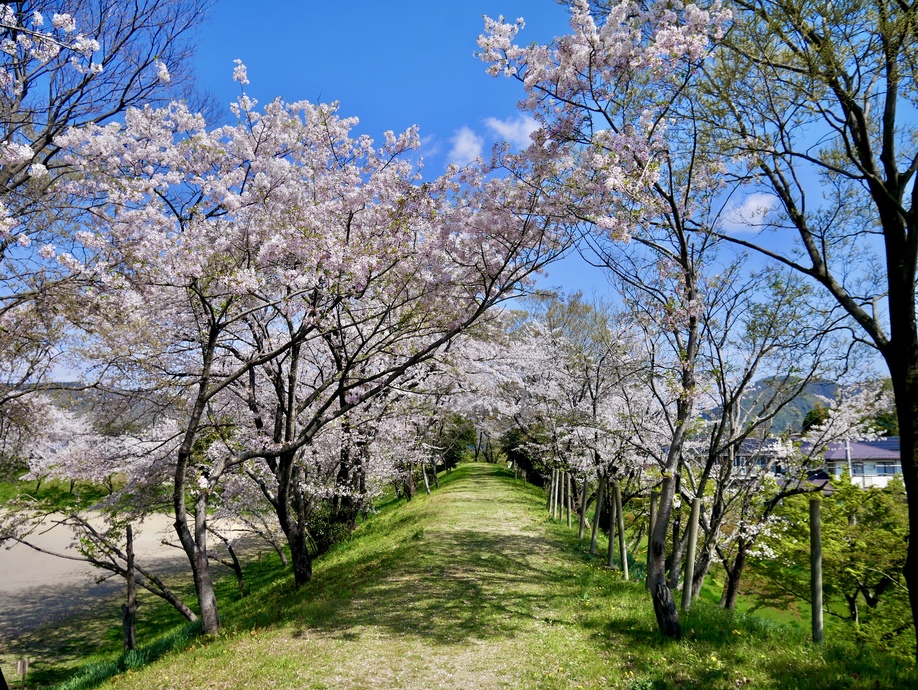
<box><xmin>479</xmin><ymin>0</ymin><xmax>729</xmax><ymax>637</ymax></box>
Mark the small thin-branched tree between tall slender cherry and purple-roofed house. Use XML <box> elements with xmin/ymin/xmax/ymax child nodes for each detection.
<box><xmin>656</xmin><ymin>263</ymin><xmax>846</xmax><ymax>593</ymax></box>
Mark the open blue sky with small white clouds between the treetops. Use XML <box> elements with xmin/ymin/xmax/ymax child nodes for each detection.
<box><xmin>195</xmin><ymin>0</ymin><xmax>608</xmax><ymax>295</ymax></box>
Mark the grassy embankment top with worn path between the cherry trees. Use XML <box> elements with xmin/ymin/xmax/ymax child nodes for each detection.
<box><xmin>54</xmin><ymin>464</ymin><xmax>918</xmax><ymax>690</ymax></box>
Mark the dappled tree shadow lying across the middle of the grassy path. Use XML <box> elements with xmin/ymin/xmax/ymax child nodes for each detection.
<box><xmin>274</xmin><ymin>530</ymin><xmax>576</xmax><ymax>645</ymax></box>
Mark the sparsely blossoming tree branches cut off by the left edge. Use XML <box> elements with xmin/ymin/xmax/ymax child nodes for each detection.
<box><xmin>0</xmin><ymin>0</ymin><xmax>209</xmax><ymax>448</ymax></box>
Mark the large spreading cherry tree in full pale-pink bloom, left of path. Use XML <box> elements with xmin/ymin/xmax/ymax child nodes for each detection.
<box><xmin>58</xmin><ymin>70</ymin><xmax>567</xmax><ymax>633</ymax></box>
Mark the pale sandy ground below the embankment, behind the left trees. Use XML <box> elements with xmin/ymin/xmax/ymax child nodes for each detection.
<box><xmin>0</xmin><ymin>508</ymin><xmax>188</xmax><ymax>647</ymax></box>
